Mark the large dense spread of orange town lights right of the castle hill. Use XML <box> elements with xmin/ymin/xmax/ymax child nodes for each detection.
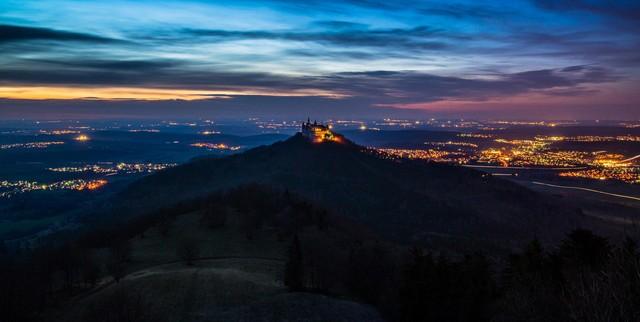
<box><xmin>374</xmin><ymin>134</ymin><xmax>640</xmax><ymax>184</ymax></box>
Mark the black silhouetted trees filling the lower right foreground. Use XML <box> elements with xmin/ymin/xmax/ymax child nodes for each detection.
<box><xmin>284</xmin><ymin>229</ymin><xmax>640</xmax><ymax>322</ymax></box>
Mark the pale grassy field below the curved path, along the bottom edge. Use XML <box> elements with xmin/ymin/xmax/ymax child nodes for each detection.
<box><xmin>67</xmin><ymin>259</ymin><xmax>382</xmax><ymax>322</ymax></box>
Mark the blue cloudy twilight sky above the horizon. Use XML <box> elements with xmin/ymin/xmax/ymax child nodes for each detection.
<box><xmin>0</xmin><ymin>0</ymin><xmax>640</xmax><ymax>120</ymax></box>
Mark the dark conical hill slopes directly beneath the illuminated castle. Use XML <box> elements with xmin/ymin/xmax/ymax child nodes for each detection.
<box><xmin>111</xmin><ymin>134</ymin><xmax>583</xmax><ymax>246</ymax></box>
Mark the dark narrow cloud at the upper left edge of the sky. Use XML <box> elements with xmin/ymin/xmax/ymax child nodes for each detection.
<box><xmin>0</xmin><ymin>25</ymin><xmax>119</xmax><ymax>44</ymax></box>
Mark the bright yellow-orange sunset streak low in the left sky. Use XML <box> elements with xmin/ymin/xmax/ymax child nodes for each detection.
<box><xmin>0</xmin><ymin>86</ymin><xmax>344</xmax><ymax>101</ymax></box>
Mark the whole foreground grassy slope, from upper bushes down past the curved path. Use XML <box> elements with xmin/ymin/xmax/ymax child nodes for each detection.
<box><xmin>56</xmin><ymin>212</ymin><xmax>381</xmax><ymax>322</ymax></box>
